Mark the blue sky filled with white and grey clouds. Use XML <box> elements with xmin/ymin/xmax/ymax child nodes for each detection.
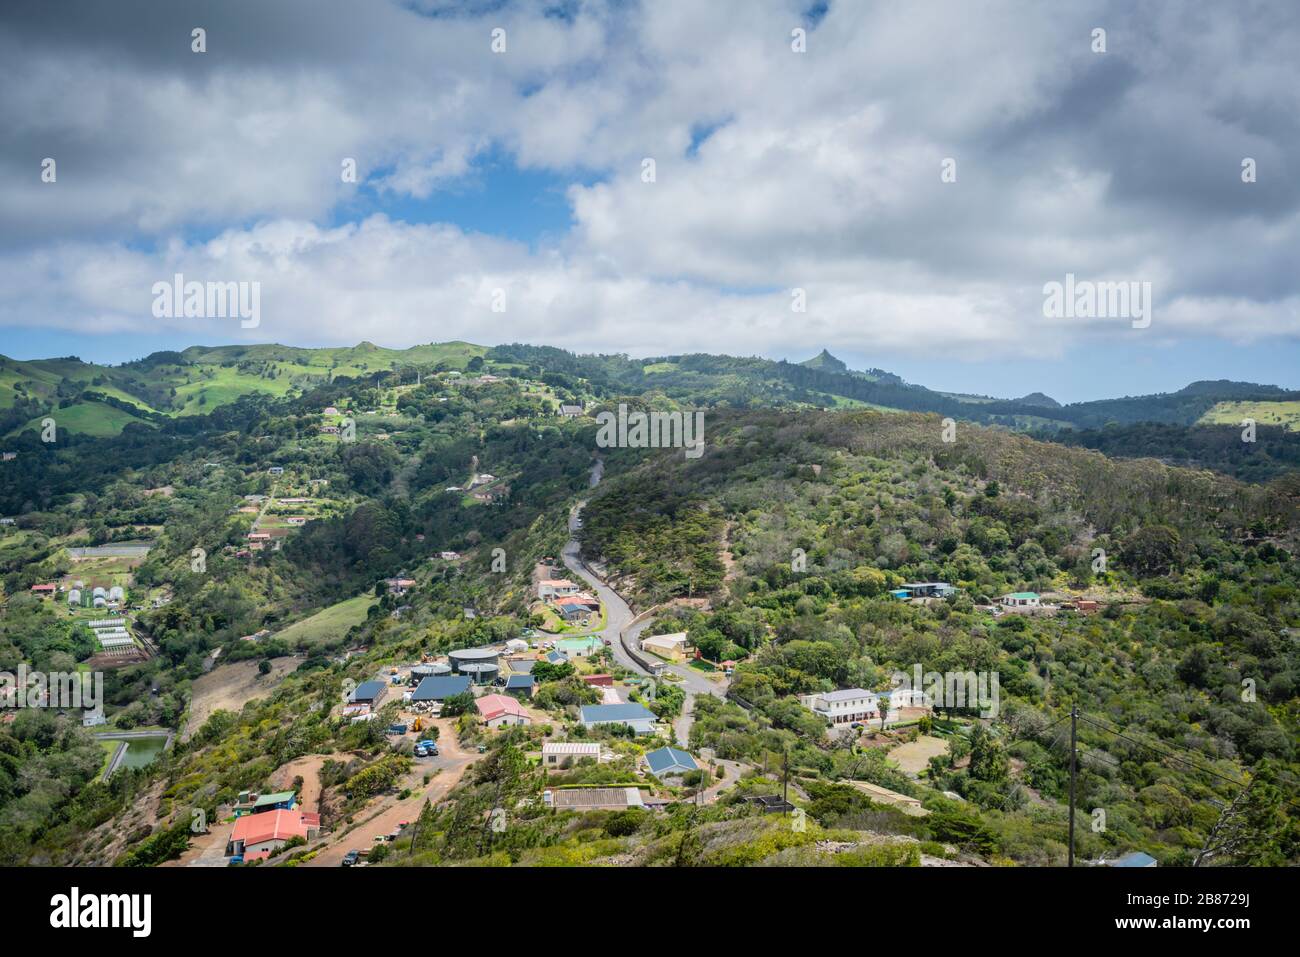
<box><xmin>0</xmin><ymin>0</ymin><xmax>1300</xmax><ymax>400</ymax></box>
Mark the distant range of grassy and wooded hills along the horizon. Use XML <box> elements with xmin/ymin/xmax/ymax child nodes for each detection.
<box><xmin>0</xmin><ymin>342</ymin><xmax>1300</xmax><ymax>436</ymax></box>
